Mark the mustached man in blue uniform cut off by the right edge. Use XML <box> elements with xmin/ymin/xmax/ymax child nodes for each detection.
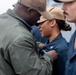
<box><xmin>54</xmin><ymin>0</ymin><xmax>76</xmax><ymax>75</ymax></box>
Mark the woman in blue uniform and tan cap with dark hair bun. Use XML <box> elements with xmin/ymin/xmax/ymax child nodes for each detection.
<box><xmin>38</xmin><ymin>7</ymin><xmax>71</xmax><ymax>75</ymax></box>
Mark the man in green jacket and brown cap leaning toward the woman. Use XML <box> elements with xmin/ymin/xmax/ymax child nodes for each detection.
<box><xmin>0</xmin><ymin>0</ymin><xmax>57</xmax><ymax>75</ymax></box>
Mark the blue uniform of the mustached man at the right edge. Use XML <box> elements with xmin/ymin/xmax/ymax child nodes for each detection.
<box><xmin>65</xmin><ymin>31</ymin><xmax>76</xmax><ymax>75</ymax></box>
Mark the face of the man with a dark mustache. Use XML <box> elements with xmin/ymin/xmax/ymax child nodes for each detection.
<box><xmin>62</xmin><ymin>1</ymin><xmax>76</xmax><ymax>23</ymax></box>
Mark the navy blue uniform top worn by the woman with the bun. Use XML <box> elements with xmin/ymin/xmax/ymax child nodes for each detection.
<box><xmin>39</xmin><ymin>33</ymin><xmax>68</xmax><ymax>75</ymax></box>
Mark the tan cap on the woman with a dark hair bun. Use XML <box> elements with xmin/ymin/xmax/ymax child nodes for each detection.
<box><xmin>37</xmin><ymin>7</ymin><xmax>65</xmax><ymax>23</ymax></box>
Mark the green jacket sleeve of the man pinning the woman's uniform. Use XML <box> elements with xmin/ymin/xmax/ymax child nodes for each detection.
<box><xmin>9</xmin><ymin>37</ymin><xmax>53</xmax><ymax>75</ymax></box>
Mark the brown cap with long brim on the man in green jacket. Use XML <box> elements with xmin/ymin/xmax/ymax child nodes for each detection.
<box><xmin>13</xmin><ymin>0</ymin><xmax>54</xmax><ymax>19</ymax></box>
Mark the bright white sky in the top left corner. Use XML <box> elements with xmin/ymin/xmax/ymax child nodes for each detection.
<box><xmin>0</xmin><ymin>0</ymin><xmax>17</xmax><ymax>14</ymax></box>
